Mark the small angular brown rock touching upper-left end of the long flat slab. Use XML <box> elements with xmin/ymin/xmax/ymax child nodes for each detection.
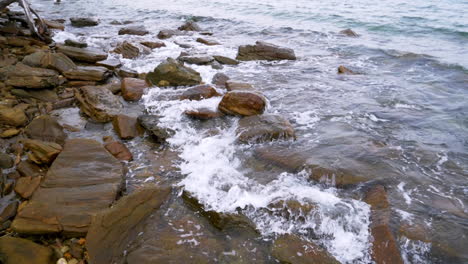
<box><xmin>23</xmin><ymin>139</ymin><xmax>62</xmax><ymax>165</ymax></box>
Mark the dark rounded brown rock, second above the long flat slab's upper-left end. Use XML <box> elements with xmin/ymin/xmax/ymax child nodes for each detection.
<box><xmin>24</xmin><ymin>115</ymin><xmax>67</xmax><ymax>145</ymax></box>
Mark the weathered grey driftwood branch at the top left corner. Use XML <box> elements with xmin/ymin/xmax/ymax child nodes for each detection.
<box><xmin>0</xmin><ymin>0</ymin><xmax>50</xmax><ymax>41</ymax></box>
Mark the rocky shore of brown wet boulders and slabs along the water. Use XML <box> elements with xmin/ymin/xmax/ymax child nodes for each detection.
<box><xmin>0</xmin><ymin>4</ymin><xmax>450</xmax><ymax>264</ymax></box>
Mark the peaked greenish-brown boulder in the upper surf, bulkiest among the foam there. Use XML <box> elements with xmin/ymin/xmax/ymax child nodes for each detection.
<box><xmin>146</xmin><ymin>58</ymin><xmax>202</xmax><ymax>86</ymax></box>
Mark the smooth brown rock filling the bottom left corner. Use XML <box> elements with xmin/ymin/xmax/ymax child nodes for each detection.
<box><xmin>0</xmin><ymin>236</ymin><xmax>53</xmax><ymax>264</ymax></box>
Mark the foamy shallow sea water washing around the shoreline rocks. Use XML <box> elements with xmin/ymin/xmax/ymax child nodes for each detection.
<box><xmin>26</xmin><ymin>0</ymin><xmax>468</xmax><ymax>263</ymax></box>
